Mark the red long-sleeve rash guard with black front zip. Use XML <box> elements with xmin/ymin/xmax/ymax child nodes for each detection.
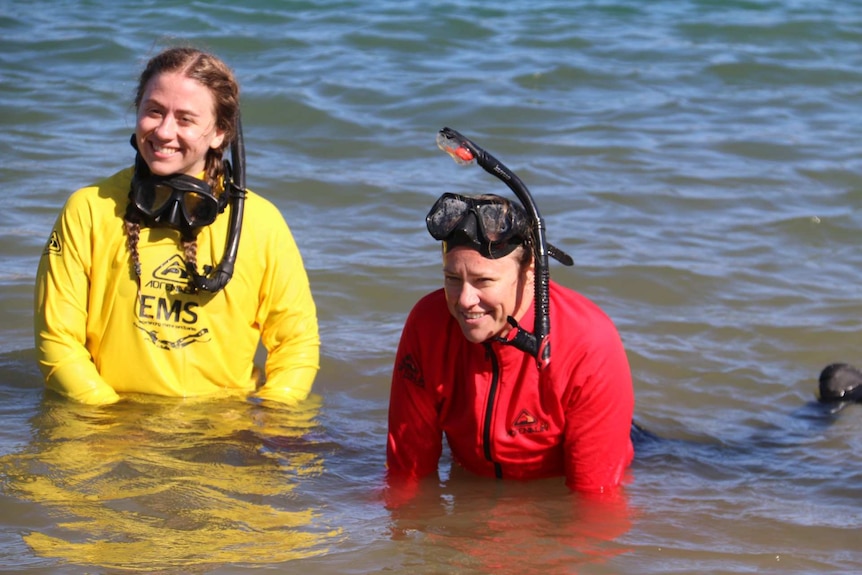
<box><xmin>387</xmin><ymin>282</ymin><xmax>634</xmax><ymax>492</ymax></box>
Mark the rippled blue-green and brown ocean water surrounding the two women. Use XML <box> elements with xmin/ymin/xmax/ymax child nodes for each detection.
<box><xmin>0</xmin><ymin>0</ymin><xmax>862</xmax><ymax>575</ymax></box>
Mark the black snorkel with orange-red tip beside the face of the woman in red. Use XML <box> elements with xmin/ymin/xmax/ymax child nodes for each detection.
<box><xmin>437</xmin><ymin>128</ymin><xmax>572</xmax><ymax>369</ymax></box>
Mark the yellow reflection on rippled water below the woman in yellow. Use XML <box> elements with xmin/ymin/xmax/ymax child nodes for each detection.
<box><xmin>0</xmin><ymin>352</ymin><xmax>340</xmax><ymax>573</ymax></box>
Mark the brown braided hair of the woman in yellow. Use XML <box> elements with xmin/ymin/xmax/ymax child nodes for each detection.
<box><xmin>123</xmin><ymin>47</ymin><xmax>239</xmax><ymax>297</ymax></box>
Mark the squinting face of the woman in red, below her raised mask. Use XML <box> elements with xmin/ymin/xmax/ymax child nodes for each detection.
<box><xmin>443</xmin><ymin>247</ymin><xmax>533</xmax><ymax>343</ymax></box>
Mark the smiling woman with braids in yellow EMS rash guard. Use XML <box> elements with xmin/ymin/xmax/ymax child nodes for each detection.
<box><xmin>34</xmin><ymin>48</ymin><xmax>320</xmax><ymax>404</ymax></box>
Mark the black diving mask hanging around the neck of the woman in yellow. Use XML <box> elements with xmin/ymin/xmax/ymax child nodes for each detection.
<box><xmin>130</xmin><ymin>174</ymin><xmax>227</xmax><ymax>231</ymax></box>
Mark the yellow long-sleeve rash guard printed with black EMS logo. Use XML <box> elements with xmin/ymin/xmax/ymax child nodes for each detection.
<box><xmin>34</xmin><ymin>168</ymin><xmax>320</xmax><ymax>404</ymax></box>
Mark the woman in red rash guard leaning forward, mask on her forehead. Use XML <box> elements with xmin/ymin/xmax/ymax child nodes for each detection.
<box><xmin>387</xmin><ymin>156</ymin><xmax>634</xmax><ymax>499</ymax></box>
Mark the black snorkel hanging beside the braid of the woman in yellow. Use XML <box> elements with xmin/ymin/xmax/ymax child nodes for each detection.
<box><xmin>186</xmin><ymin>112</ymin><xmax>247</xmax><ymax>293</ymax></box>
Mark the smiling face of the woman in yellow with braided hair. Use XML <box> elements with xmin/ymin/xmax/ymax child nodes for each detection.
<box><xmin>135</xmin><ymin>72</ymin><xmax>225</xmax><ymax>176</ymax></box>
